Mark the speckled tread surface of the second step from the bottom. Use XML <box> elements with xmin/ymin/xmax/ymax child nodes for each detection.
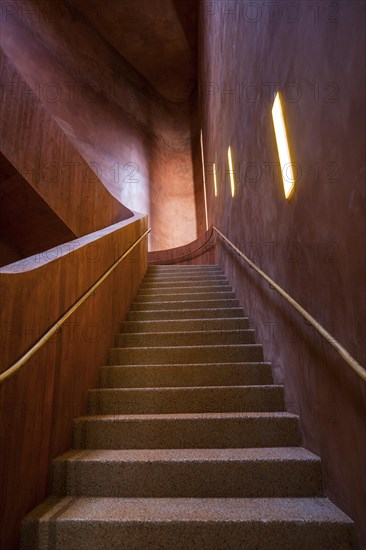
<box><xmin>54</xmin><ymin>447</ymin><xmax>320</xmax><ymax>462</ymax></box>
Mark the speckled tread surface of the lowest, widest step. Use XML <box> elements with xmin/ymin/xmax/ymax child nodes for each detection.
<box><xmin>26</xmin><ymin>497</ymin><xmax>352</xmax><ymax>526</ymax></box>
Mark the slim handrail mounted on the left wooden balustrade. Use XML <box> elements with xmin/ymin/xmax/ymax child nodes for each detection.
<box><xmin>0</xmin><ymin>228</ymin><xmax>151</xmax><ymax>384</ymax></box>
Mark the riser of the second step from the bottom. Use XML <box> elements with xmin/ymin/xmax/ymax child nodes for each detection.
<box><xmin>53</xmin><ymin>460</ymin><xmax>323</xmax><ymax>498</ymax></box>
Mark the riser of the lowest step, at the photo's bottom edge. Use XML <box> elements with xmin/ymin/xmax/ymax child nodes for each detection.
<box><xmin>22</xmin><ymin>518</ymin><xmax>356</xmax><ymax>550</ymax></box>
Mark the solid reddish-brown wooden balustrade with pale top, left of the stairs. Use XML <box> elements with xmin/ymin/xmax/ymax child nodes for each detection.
<box><xmin>0</xmin><ymin>216</ymin><xmax>147</xmax><ymax>550</ymax></box>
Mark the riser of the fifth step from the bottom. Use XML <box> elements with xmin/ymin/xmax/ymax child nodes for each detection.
<box><xmin>100</xmin><ymin>363</ymin><xmax>273</xmax><ymax>388</ymax></box>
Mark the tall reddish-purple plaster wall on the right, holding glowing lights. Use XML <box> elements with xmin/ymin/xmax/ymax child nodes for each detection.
<box><xmin>200</xmin><ymin>0</ymin><xmax>366</xmax><ymax>548</ymax></box>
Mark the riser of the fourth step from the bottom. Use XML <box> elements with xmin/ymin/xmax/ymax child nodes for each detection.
<box><xmin>88</xmin><ymin>384</ymin><xmax>285</xmax><ymax>415</ymax></box>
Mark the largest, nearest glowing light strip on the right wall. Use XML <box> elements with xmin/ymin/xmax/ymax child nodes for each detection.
<box><xmin>272</xmin><ymin>92</ymin><xmax>295</xmax><ymax>199</ymax></box>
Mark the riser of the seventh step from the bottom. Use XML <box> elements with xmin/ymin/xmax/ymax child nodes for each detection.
<box><xmin>115</xmin><ymin>329</ymin><xmax>255</xmax><ymax>347</ymax></box>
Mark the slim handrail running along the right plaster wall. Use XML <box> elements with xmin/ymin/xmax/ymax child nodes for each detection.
<box><xmin>213</xmin><ymin>226</ymin><xmax>366</xmax><ymax>381</ymax></box>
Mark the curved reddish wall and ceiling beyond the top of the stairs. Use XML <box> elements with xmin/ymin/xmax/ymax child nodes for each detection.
<box><xmin>0</xmin><ymin>0</ymin><xmax>204</xmax><ymax>249</ymax></box>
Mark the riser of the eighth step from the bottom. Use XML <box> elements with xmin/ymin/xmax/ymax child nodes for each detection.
<box><xmin>121</xmin><ymin>317</ymin><xmax>249</xmax><ymax>333</ymax></box>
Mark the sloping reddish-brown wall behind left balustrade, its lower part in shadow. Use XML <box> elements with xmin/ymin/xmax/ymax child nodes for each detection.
<box><xmin>0</xmin><ymin>49</ymin><xmax>133</xmax><ymax>244</ymax></box>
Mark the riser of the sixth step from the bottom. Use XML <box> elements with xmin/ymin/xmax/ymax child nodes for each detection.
<box><xmin>109</xmin><ymin>344</ymin><xmax>263</xmax><ymax>365</ymax></box>
